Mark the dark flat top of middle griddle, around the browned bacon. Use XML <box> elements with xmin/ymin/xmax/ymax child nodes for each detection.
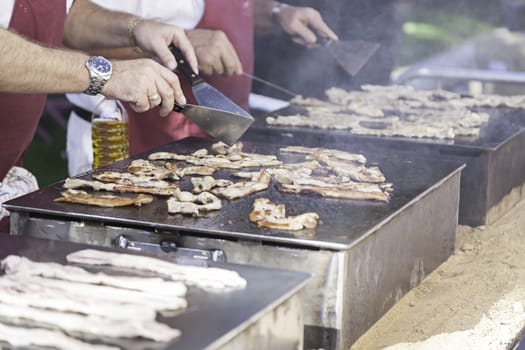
<box><xmin>5</xmin><ymin>139</ymin><xmax>461</xmax><ymax>250</ymax></box>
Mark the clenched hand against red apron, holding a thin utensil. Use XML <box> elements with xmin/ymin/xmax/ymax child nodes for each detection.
<box><xmin>186</xmin><ymin>29</ymin><xmax>242</xmax><ymax>76</ymax></box>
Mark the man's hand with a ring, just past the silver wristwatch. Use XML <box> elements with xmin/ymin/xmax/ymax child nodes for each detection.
<box><xmin>102</xmin><ymin>59</ymin><xmax>186</xmax><ymax>116</ymax></box>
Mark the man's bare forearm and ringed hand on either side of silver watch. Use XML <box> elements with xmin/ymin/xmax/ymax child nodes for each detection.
<box><xmin>0</xmin><ymin>29</ymin><xmax>186</xmax><ymax>115</ymax></box>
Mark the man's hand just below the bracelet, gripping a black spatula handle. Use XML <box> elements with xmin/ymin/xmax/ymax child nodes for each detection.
<box><xmin>133</xmin><ymin>20</ymin><xmax>199</xmax><ymax>72</ymax></box>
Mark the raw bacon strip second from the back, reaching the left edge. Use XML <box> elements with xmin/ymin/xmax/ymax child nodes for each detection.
<box><xmin>1</xmin><ymin>255</ymin><xmax>187</xmax><ymax>297</ymax></box>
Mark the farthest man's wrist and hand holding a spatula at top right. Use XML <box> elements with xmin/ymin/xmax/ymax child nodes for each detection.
<box><xmin>254</xmin><ymin>0</ymin><xmax>338</xmax><ymax>47</ymax></box>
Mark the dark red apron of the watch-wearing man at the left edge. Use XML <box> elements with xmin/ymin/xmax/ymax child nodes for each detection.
<box><xmin>0</xmin><ymin>0</ymin><xmax>66</xmax><ymax>232</ymax></box>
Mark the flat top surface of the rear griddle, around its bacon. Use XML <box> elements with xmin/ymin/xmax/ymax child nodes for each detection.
<box><xmin>247</xmin><ymin>106</ymin><xmax>525</xmax><ymax>151</ymax></box>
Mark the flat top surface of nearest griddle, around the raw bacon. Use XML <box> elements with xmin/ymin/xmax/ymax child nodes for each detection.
<box><xmin>0</xmin><ymin>234</ymin><xmax>308</xmax><ymax>350</ymax></box>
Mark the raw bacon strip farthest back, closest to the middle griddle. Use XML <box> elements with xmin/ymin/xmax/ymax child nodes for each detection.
<box><xmin>66</xmin><ymin>249</ymin><xmax>246</xmax><ymax>290</ymax></box>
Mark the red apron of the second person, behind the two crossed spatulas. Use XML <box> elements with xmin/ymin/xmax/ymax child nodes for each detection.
<box><xmin>128</xmin><ymin>0</ymin><xmax>253</xmax><ymax>155</ymax></box>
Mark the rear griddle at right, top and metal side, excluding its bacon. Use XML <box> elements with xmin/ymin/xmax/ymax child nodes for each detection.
<box><xmin>243</xmin><ymin>107</ymin><xmax>525</xmax><ymax>226</ymax></box>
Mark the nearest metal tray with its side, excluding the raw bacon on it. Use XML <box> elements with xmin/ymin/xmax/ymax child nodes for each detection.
<box><xmin>0</xmin><ymin>234</ymin><xmax>308</xmax><ymax>350</ymax></box>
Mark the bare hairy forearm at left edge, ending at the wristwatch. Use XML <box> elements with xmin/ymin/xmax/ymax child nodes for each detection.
<box><xmin>0</xmin><ymin>29</ymin><xmax>89</xmax><ymax>93</ymax></box>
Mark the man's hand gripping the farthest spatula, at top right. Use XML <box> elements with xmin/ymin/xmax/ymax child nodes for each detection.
<box><xmin>275</xmin><ymin>6</ymin><xmax>338</xmax><ymax>47</ymax></box>
